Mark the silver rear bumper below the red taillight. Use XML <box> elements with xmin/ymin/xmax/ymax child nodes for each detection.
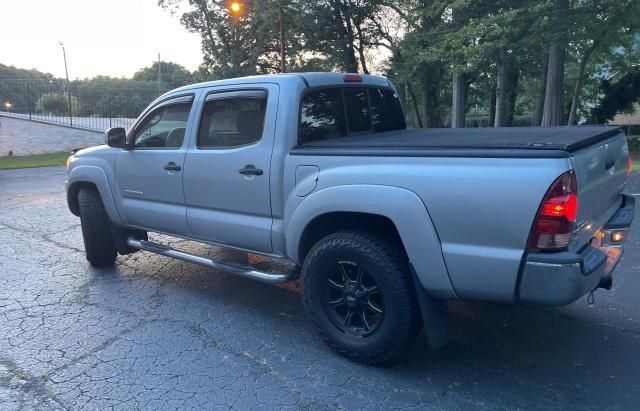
<box><xmin>517</xmin><ymin>195</ymin><xmax>635</xmax><ymax>306</ymax></box>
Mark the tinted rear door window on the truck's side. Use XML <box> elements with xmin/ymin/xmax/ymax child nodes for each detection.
<box><xmin>198</xmin><ymin>94</ymin><xmax>267</xmax><ymax>148</ymax></box>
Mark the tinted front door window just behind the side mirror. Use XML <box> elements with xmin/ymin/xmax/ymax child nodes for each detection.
<box><xmin>133</xmin><ymin>102</ymin><xmax>191</xmax><ymax>148</ymax></box>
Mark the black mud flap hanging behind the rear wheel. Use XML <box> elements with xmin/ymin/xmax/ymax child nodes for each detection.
<box><xmin>411</xmin><ymin>267</ymin><xmax>450</xmax><ymax>350</ymax></box>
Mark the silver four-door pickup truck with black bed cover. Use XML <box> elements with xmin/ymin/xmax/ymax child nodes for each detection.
<box><xmin>67</xmin><ymin>73</ymin><xmax>634</xmax><ymax>363</ymax></box>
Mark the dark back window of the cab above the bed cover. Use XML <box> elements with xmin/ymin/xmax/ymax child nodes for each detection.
<box><xmin>299</xmin><ymin>87</ymin><xmax>407</xmax><ymax>144</ymax></box>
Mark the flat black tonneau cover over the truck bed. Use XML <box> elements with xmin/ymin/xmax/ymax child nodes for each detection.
<box><xmin>291</xmin><ymin>126</ymin><xmax>622</xmax><ymax>157</ymax></box>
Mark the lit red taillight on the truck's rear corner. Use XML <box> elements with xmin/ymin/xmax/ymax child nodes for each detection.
<box><xmin>528</xmin><ymin>171</ymin><xmax>578</xmax><ymax>250</ymax></box>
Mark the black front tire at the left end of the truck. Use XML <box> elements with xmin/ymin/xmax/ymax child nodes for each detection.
<box><xmin>78</xmin><ymin>188</ymin><xmax>118</xmax><ymax>267</ymax></box>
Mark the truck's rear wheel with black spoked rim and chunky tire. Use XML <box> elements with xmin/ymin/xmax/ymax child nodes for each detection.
<box><xmin>302</xmin><ymin>231</ymin><xmax>420</xmax><ymax>364</ymax></box>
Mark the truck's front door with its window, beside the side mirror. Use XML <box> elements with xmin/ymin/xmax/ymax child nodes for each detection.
<box><xmin>115</xmin><ymin>95</ymin><xmax>194</xmax><ymax>235</ymax></box>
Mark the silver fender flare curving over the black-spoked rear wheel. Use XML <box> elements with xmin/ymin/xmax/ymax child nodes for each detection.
<box><xmin>285</xmin><ymin>185</ymin><xmax>457</xmax><ymax>299</ymax></box>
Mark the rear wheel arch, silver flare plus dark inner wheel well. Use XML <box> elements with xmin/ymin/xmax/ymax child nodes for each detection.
<box><xmin>285</xmin><ymin>185</ymin><xmax>457</xmax><ymax>298</ymax></box>
